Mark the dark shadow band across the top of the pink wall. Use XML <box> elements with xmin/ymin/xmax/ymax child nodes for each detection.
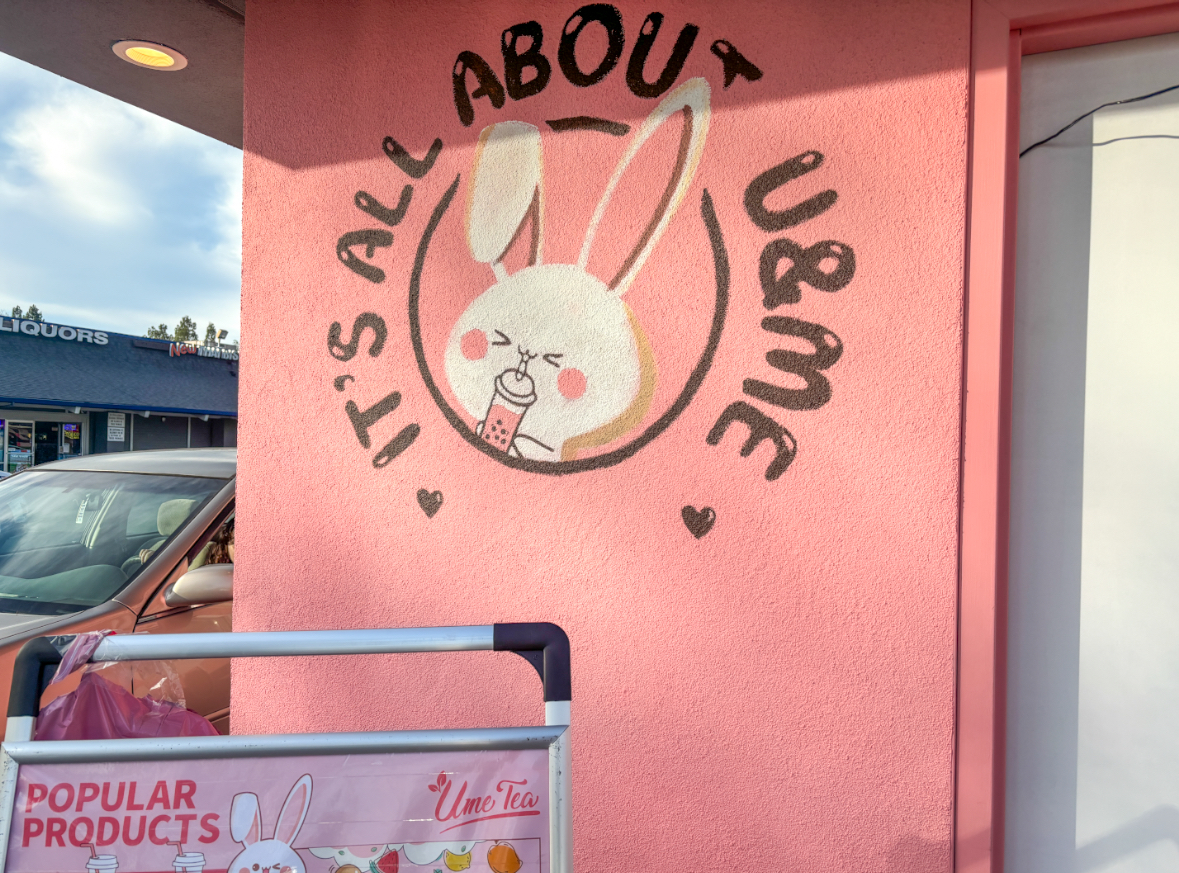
<box><xmin>245</xmin><ymin>0</ymin><xmax>970</xmax><ymax>169</ymax></box>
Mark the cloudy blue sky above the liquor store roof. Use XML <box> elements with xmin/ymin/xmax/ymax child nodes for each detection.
<box><xmin>0</xmin><ymin>46</ymin><xmax>242</xmax><ymax>342</ymax></box>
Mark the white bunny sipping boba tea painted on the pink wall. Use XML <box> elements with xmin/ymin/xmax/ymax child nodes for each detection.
<box><xmin>444</xmin><ymin>79</ymin><xmax>710</xmax><ymax>461</ymax></box>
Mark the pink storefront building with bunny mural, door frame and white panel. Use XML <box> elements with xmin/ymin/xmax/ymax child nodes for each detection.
<box><xmin>0</xmin><ymin>0</ymin><xmax>1179</xmax><ymax>873</ymax></box>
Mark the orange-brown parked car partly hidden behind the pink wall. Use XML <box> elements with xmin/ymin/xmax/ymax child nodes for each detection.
<box><xmin>0</xmin><ymin>448</ymin><xmax>237</xmax><ymax>733</ymax></box>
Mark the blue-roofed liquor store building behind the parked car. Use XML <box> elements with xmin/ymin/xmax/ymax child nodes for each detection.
<box><xmin>0</xmin><ymin>316</ymin><xmax>238</xmax><ymax>473</ymax></box>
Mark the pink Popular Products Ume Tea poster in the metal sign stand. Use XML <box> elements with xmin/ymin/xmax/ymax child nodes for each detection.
<box><xmin>5</xmin><ymin>749</ymin><xmax>549</xmax><ymax>873</ymax></box>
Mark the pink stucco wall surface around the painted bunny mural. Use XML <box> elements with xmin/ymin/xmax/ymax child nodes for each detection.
<box><xmin>233</xmin><ymin>0</ymin><xmax>969</xmax><ymax>873</ymax></box>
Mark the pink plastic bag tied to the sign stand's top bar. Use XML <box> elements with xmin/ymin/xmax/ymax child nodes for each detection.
<box><xmin>33</xmin><ymin>631</ymin><xmax>217</xmax><ymax>740</ymax></box>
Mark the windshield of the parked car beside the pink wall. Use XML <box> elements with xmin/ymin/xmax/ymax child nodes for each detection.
<box><xmin>0</xmin><ymin>470</ymin><xmax>225</xmax><ymax>615</ymax></box>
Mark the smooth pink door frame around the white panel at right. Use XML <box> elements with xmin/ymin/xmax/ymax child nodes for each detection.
<box><xmin>954</xmin><ymin>0</ymin><xmax>1179</xmax><ymax>873</ymax></box>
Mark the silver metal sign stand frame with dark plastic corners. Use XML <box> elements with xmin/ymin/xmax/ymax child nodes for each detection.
<box><xmin>0</xmin><ymin>622</ymin><xmax>573</xmax><ymax>873</ymax></box>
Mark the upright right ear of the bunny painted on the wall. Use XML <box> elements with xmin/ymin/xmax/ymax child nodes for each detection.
<box><xmin>578</xmin><ymin>78</ymin><xmax>711</xmax><ymax>295</ymax></box>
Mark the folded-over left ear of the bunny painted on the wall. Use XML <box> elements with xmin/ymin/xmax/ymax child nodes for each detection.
<box><xmin>466</xmin><ymin>122</ymin><xmax>544</xmax><ymax>278</ymax></box>
